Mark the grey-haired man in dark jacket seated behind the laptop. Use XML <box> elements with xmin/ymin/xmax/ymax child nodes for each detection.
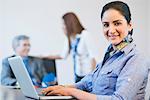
<box><xmin>1</xmin><ymin>35</ymin><xmax>46</xmax><ymax>87</ymax></box>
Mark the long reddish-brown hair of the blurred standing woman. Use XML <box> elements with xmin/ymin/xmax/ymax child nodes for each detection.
<box><xmin>62</xmin><ymin>12</ymin><xmax>84</xmax><ymax>53</ymax></box>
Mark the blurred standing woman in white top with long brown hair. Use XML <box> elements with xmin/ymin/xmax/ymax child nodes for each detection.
<box><xmin>48</xmin><ymin>12</ymin><xmax>96</xmax><ymax>82</ymax></box>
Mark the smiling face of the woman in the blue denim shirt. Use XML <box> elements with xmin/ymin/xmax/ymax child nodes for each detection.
<box><xmin>102</xmin><ymin>9</ymin><xmax>132</xmax><ymax>45</ymax></box>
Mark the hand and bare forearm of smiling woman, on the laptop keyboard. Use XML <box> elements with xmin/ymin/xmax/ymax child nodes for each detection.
<box><xmin>42</xmin><ymin>85</ymin><xmax>96</xmax><ymax>100</ymax></box>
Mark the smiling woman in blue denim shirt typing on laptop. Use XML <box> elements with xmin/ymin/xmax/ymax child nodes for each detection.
<box><xmin>42</xmin><ymin>1</ymin><xmax>149</xmax><ymax>100</ymax></box>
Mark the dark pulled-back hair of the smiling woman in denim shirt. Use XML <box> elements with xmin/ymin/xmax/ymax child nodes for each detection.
<box><xmin>101</xmin><ymin>1</ymin><xmax>131</xmax><ymax>23</ymax></box>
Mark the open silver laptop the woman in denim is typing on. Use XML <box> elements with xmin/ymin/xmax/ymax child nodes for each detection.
<box><xmin>8</xmin><ymin>56</ymin><xmax>73</xmax><ymax>100</ymax></box>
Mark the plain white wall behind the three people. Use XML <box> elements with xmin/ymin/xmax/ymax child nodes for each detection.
<box><xmin>0</xmin><ymin>0</ymin><xmax>150</xmax><ymax>84</ymax></box>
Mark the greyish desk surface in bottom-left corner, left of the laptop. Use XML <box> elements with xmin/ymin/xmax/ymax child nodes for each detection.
<box><xmin>0</xmin><ymin>86</ymin><xmax>33</xmax><ymax>100</ymax></box>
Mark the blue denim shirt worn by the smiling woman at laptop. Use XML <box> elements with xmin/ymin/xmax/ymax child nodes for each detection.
<box><xmin>75</xmin><ymin>43</ymin><xmax>149</xmax><ymax>100</ymax></box>
